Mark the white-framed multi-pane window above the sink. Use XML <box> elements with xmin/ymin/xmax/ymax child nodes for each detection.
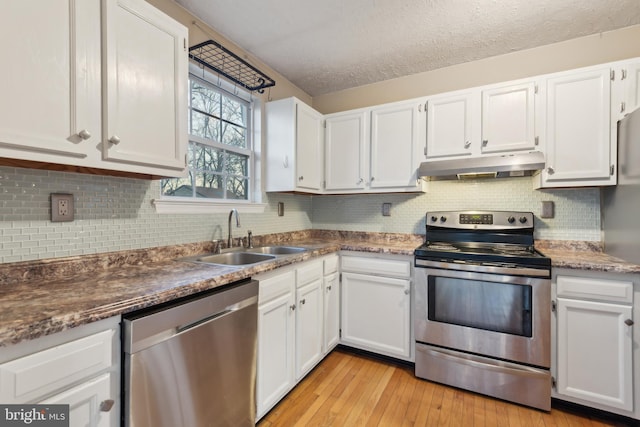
<box><xmin>161</xmin><ymin>75</ymin><xmax>253</xmax><ymax>201</ymax></box>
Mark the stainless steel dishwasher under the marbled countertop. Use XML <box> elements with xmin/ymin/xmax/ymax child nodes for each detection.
<box><xmin>123</xmin><ymin>280</ymin><xmax>258</xmax><ymax>427</ymax></box>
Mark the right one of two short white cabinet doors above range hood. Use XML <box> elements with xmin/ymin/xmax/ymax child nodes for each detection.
<box><xmin>481</xmin><ymin>82</ymin><xmax>535</xmax><ymax>153</ymax></box>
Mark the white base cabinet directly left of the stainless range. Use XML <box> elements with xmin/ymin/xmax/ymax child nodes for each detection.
<box><xmin>340</xmin><ymin>255</ymin><xmax>413</xmax><ymax>360</ymax></box>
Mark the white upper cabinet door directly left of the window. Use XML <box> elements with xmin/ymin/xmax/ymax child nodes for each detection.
<box><xmin>102</xmin><ymin>0</ymin><xmax>188</xmax><ymax>176</ymax></box>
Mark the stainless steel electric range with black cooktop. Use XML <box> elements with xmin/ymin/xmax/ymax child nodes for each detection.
<box><xmin>415</xmin><ymin>211</ymin><xmax>551</xmax><ymax>411</ymax></box>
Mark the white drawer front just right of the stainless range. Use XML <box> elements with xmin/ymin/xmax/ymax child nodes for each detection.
<box><xmin>557</xmin><ymin>276</ymin><xmax>633</xmax><ymax>304</ymax></box>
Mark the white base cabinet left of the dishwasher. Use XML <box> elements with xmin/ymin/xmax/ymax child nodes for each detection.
<box><xmin>0</xmin><ymin>317</ymin><xmax>120</xmax><ymax>427</ymax></box>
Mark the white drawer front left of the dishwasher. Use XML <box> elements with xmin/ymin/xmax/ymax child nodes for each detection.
<box><xmin>0</xmin><ymin>330</ymin><xmax>115</xmax><ymax>403</ymax></box>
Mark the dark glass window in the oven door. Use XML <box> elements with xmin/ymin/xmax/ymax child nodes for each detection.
<box><xmin>427</xmin><ymin>276</ymin><xmax>532</xmax><ymax>337</ymax></box>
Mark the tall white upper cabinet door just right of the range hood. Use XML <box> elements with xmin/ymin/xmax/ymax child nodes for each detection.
<box><xmin>542</xmin><ymin>67</ymin><xmax>615</xmax><ymax>186</ymax></box>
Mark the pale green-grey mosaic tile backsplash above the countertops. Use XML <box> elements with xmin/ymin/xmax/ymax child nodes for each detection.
<box><xmin>0</xmin><ymin>167</ymin><xmax>601</xmax><ymax>262</ymax></box>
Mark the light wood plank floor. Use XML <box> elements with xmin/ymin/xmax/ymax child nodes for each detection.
<box><xmin>258</xmin><ymin>349</ymin><xmax>626</xmax><ymax>427</ymax></box>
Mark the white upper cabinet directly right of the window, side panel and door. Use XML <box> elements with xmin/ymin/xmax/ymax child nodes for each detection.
<box><xmin>265</xmin><ymin>98</ymin><xmax>324</xmax><ymax>193</ymax></box>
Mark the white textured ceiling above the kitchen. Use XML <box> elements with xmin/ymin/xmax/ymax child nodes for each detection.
<box><xmin>176</xmin><ymin>0</ymin><xmax>640</xmax><ymax>96</ymax></box>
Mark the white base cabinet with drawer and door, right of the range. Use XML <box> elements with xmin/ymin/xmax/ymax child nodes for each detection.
<box><xmin>552</xmin><ymin>270</ymin><xmax>640</xmax><ymax>418</ymax></box>
